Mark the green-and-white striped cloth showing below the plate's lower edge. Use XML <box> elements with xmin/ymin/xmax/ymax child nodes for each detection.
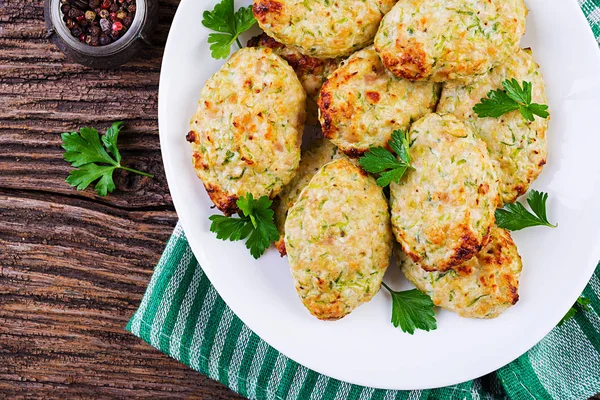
<box><xmin>127</xmin><ymin>225</ymin><xmax>600</xmax><ymax>400</ymax></box>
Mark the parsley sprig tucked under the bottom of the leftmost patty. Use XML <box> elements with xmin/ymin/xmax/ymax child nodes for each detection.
<box><xmin>209</xmin><ymin>193</ymin><xmax>279</xmax><ymax>258</ymax></box>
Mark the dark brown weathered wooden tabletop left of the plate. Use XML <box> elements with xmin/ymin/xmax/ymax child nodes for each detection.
<box><xmin>0</xmin><ymin>0</ymin><xmax>244</xmax><ymax>399</ymax></box>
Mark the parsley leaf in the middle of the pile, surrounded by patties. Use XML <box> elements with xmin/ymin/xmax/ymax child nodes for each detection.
<box><xmin>358</xmin><ymin>131</ymin><xmax>412</xmax><ymax>187</ymax></box>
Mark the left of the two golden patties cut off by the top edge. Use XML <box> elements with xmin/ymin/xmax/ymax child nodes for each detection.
<box><xmin>252</xmin><ymin>0</ymin><xmax>396</xmax><ymax>58</ymax></box>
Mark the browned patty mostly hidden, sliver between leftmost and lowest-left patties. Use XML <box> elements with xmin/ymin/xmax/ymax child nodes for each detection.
<box><xmin>274</xmin><ymin>138</ymin><xmax>343</xmax><ymax>256</ymax></box>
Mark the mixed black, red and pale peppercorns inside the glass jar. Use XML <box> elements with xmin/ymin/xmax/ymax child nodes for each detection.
<box><xmin>60</xmin><ymin>0</ymin><xmax>136</xmax><ymax>46</ymax></box>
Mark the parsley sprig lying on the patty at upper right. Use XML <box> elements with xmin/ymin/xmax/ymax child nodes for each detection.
<box><xmin>473</xmin><ymin>78</ymin><xmax>550</xmax><ymax>122</ymax></box>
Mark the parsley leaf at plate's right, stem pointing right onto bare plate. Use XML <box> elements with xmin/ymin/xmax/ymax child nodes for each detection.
<box><xmin>496</xmin><ymin>190</ymin><xmax>558</xmax><ymax>231</ymax></box>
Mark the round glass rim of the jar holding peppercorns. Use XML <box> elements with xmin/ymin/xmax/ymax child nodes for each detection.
<box><xmin>49</xmin><ymin>0</ymin><xmax>147</xmax><ymax>57</ymax></box>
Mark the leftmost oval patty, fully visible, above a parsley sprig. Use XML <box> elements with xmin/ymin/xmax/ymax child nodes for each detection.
<box><xmin>186</xmin><ymin>48</ymin><xmax>306</xmax><ymax>215</ymax></box>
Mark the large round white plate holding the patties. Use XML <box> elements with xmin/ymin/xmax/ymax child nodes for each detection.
<box><xmin>159</xmin><ymin>0</ymin><xmax>600</xmax><ymax>389</ymax></box>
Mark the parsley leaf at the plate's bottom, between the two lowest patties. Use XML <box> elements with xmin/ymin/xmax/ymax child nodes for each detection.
<box><xmin>382</xmin><ymin>282</ymin><xmax>437</xmax><ymax>335</ymax></box>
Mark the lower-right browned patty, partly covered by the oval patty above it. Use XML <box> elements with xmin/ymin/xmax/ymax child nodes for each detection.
<box><xmin>397</xmin><ymin>226</ymin><xmax>522</xmax><ymax>318</ymax></box>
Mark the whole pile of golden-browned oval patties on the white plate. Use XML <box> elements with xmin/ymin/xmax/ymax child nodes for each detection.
<box><xmin>188</xmin><ymin>0</ymin><xmax>548</xmax><ymax>320</ymax></box>
